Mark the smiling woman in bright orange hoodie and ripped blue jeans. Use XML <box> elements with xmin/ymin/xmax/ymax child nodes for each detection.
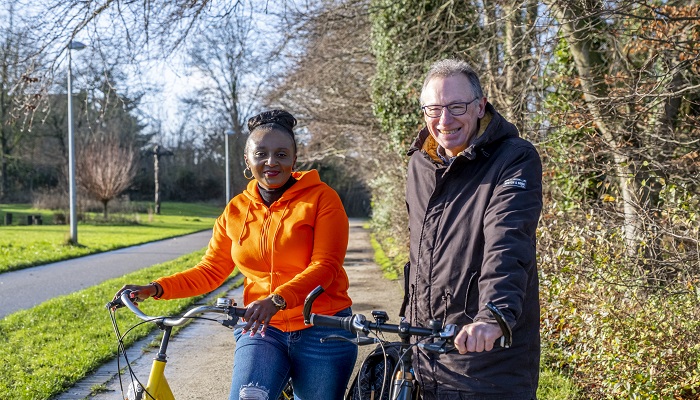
<box><xmin>117</xmin><ymin>110</ymin><xmax>357</xmax><ymax>400</ymax></box>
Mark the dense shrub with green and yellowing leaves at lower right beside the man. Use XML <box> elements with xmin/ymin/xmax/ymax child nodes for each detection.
<box><xmin>539</xmin><ymin>205</ymin><xmax>700</xmax><ymax>399</ymax></box>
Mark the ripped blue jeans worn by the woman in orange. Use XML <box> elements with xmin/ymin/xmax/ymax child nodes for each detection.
<box><xmin>229</xmin><ymin>308</ymin><xmax>357</xmax><ymax>400</ymax></box>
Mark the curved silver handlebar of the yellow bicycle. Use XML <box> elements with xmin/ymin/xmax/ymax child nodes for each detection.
<box><xmin>106</xmin><ymin>289</ymin><xmax>246</xmax><ymax>327</ymax></box>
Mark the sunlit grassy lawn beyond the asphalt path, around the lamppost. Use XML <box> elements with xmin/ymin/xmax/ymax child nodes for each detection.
<box><xmin>0</xmin><ymin>203</ymin><xmax>223</xmax><ymax>273</ymax></box>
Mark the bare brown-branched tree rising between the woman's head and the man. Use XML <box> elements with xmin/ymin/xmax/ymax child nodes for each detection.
<box><xmin>266</xmin><ymin>0</ymin><xmax>378</xmax><ymax>215</ymax></box>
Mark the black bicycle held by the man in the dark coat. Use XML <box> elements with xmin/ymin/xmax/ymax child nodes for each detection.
<box><xmin>303</xmin><ymin>286</ymin><xmax>512</xmax><ymax>400</ymax></box>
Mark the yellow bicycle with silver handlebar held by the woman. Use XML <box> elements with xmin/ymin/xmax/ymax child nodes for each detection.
<box><xmin>106</xmin><ymin>290</ymin><xmax>294</xmax><ymax>400</ymax></box>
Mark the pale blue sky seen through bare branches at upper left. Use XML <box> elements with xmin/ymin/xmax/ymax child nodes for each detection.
<box><xmin>0</xmin><ymin>0</ymin><xmax>306</xmax><ymax>142</ymax></box>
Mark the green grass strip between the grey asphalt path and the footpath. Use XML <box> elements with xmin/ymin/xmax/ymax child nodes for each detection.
<box><xmin>0</xmin><ymin>250</ymin><xmax>241</xmax><ymax>399</ymax></box>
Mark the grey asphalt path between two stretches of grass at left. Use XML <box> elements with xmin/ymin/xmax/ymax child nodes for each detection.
<box><xmin>0</xmin><ymin>230</ymin><xmax>211</xmax><ymax>318</ymax></box>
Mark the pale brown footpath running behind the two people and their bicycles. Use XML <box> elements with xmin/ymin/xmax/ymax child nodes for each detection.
<box><xmin>64</xmin><ymin>219</ymin><xmax>402</xmax><ymax>400</ymax></box>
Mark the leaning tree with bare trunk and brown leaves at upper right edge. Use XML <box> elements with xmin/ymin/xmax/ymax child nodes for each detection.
<box><xmin>549</xmin><ymin>1</ymin><xmax>700</xmax><ymax>266</ymax></box>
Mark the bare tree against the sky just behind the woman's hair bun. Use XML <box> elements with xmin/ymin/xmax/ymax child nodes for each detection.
<box><xmin>183</xmin><ymin>3</ymin><xmax>274</xmax><ymax>201</ymax></box>
